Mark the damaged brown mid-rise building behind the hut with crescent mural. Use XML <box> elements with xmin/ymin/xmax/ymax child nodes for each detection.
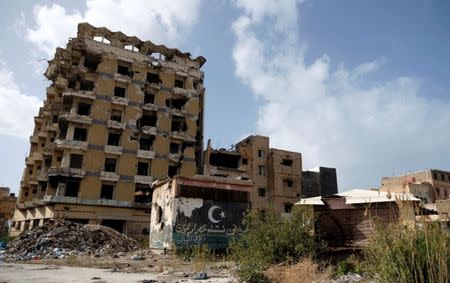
<box><xmin>203</xmin><ymin>135</ymin><xmax>302</xmax><ymax>213</ymax></box>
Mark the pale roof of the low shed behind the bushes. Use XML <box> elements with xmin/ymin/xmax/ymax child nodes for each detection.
<box><xmin>296</xmin><ymin>189</ymin><xmax>420</xmax><ymax>205</ymax></box>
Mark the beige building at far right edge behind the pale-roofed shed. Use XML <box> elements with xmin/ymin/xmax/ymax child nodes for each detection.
<box><xmin>380</xmin><ymin>169</ymin><xmax>450</xmax><ymax>204</ymax></box>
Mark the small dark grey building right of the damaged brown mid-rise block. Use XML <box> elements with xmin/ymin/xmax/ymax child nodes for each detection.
<box><xmin>302</xmin><ymin>167</ymin><xmax>338</xmax><ymax>198</ymax></box>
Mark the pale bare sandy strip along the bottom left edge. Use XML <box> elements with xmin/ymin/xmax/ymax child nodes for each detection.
<box><xmin>0</xmin><ymin>263</ymin><xmax>237</xmax><ymax>283</ymax></box>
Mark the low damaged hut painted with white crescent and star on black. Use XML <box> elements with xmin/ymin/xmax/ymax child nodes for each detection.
<box><xmin>150</xmin><ymin>176</ymin><xmax>253</xmax><ymax>250</ymax></box>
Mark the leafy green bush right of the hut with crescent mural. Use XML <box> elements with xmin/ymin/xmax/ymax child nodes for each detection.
<box><xmin>231</xmin><ymin>206</ymin><xmax>321</xmax><ymax>282</ymax></box>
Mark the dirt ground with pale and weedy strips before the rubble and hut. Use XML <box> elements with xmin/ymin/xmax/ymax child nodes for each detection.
<box><xmin>0</xmin><ymin>251</ymin><xmax>238</xmax><ymax>283</ymax></box>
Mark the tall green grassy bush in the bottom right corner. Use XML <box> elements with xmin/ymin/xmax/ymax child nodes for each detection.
<box><xmin>364</xmin><ymin>223</ymin><xmax>450</xmax><ymax>283</ymax></box>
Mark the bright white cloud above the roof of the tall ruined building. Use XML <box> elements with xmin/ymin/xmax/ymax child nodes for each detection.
<box><xmin>20</xmin><ymin>0</ymin><xmax>201</xmax><ymax>58</ymax></box>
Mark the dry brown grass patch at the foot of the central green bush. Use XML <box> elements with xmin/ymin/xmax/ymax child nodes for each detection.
<box><xmin>264</xmin><ymin>258</ymin><xmax>332</xmax><ymax>283</ymax></box>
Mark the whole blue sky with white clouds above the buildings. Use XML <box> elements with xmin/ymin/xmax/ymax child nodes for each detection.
<box><xmin>0</xmin><ymin>0</ymin><xmax>450</xmax><ymax>192</ymax></box>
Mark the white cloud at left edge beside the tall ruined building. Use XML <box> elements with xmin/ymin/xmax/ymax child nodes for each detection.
<box><xmin>0</xmin><ymin>63</ymin><xmax>42</xmax><ymax>138</ymax></box>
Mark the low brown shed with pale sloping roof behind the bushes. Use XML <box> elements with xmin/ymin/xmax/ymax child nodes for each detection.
<box><xmin>297</xmin><ymin>190</ymin><xmax>420</xmax><ymax>247</ymax></box>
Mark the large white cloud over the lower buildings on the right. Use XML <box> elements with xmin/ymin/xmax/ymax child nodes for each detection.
<box><xmin>233</xmin><ymin>0</ymin><xmax>450</xmax><ymax>189</ymax></box>
